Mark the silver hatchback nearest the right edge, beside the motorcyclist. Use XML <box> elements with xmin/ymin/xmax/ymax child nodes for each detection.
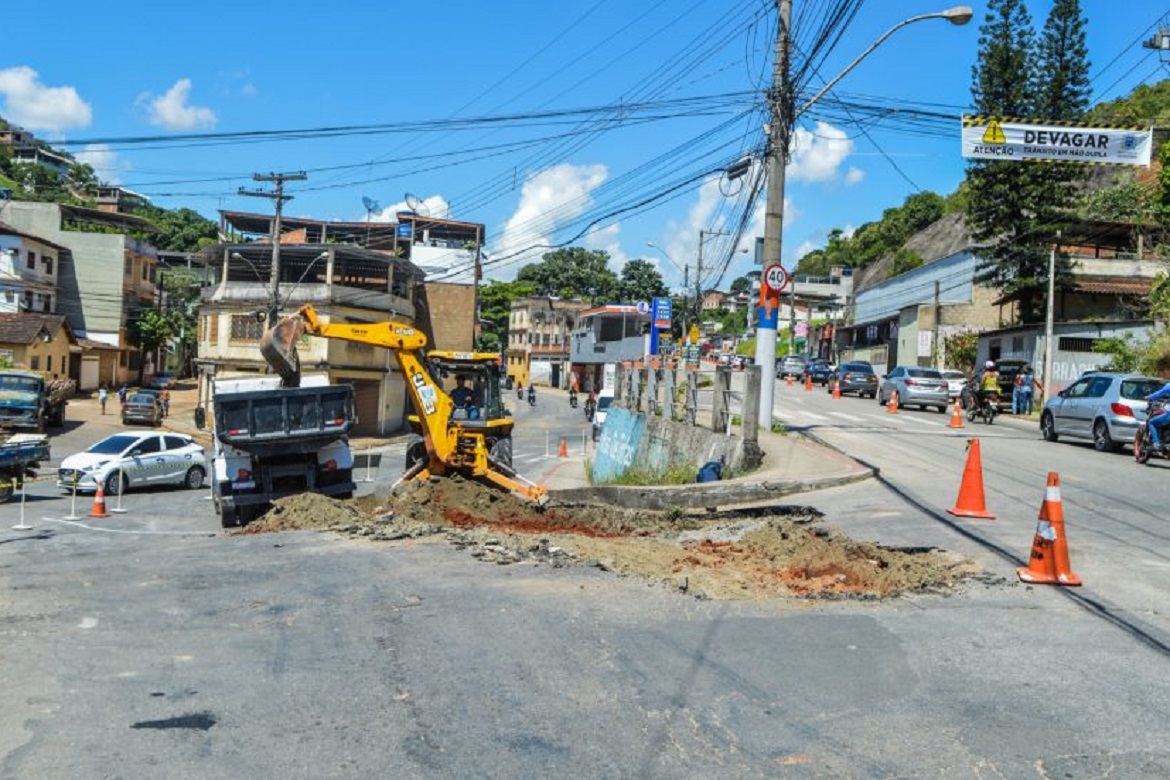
<box><xmin>1040</xmin><ymin>372</ymin><xmax>1166</xmax><ymax>453</ymax></box>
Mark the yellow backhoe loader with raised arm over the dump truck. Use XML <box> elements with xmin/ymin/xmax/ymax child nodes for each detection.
<box><xmin>260</xmin><ymin>305</ymin><xmax>548</xmax><ymax>505</ymax></box>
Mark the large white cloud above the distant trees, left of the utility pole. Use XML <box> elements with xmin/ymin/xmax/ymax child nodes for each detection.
<box><xmin>491</xmin><ymin>164</ymin><xmax>610</xmax><ymax>268</ymax></box>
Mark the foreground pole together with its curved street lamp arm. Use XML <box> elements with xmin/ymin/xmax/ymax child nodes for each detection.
<box><xmin>756</xmin><ymin>0</ymin><xmax>975</xmax><ymax>428</ymax></box>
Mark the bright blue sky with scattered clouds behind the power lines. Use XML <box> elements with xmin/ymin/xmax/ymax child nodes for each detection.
<box><xmin>0</xmin><ymin>0</ymin><xmax>1168</xmax><ymax>288</ymax></box>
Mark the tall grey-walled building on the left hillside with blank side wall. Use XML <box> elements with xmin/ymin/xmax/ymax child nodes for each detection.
<box><xmin>2</xmin><ymin>200</ymin><xmax>158</xmax><ymax>389</ymax></box>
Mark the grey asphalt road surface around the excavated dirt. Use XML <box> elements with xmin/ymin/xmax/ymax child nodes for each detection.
<box><xmin>0</xmin><ymin>391</ymin><xmax>1170</xmax><ymax>779</ymax></box>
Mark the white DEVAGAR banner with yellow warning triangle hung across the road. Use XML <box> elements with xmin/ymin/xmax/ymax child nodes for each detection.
<box><xmin>963</xmin><ymin>116</ymin><xmax>1154</xmax><ymax>167</ymax></box>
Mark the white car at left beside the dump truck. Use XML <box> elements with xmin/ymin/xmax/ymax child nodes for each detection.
<box><xmin>57</xmin><ymin>432</ymin><xmax>207</xmax><ymax>496</ymax></box>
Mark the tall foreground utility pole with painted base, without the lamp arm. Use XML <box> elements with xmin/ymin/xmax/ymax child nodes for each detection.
<box><xmin>756</xmin><ymin>0</ymin><xmax>796</xmax><ymax>429</ymax></box>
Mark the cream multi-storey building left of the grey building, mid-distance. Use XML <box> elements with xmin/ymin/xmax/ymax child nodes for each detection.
<box><xmin>504</xmin><ymin>297</ymin><xmax>590</xmax><ymax>387</ymax></box>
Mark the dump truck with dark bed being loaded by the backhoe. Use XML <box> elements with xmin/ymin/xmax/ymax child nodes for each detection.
<box><xmin>197</xmin><ymin>375</ymin><xmax>357</xmax><ymax>529</ymax></box>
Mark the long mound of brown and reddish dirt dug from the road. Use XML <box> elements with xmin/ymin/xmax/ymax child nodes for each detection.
<box><xmin>240</xmin><ymin>478</ymin><xmax>978</xmax><ymax>599</ymax></box>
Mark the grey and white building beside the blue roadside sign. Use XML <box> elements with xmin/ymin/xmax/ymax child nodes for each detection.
<box><xmin>570</xmin><ymin>304</ymin><xmax>651</xmax><ymax>393</ymax></box>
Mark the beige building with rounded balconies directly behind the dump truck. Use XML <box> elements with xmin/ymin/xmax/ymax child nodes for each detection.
<box><xmin>195</xmin><ymin>243</ymin><xmax>422</xmax><ymax>434</ymax></box>
